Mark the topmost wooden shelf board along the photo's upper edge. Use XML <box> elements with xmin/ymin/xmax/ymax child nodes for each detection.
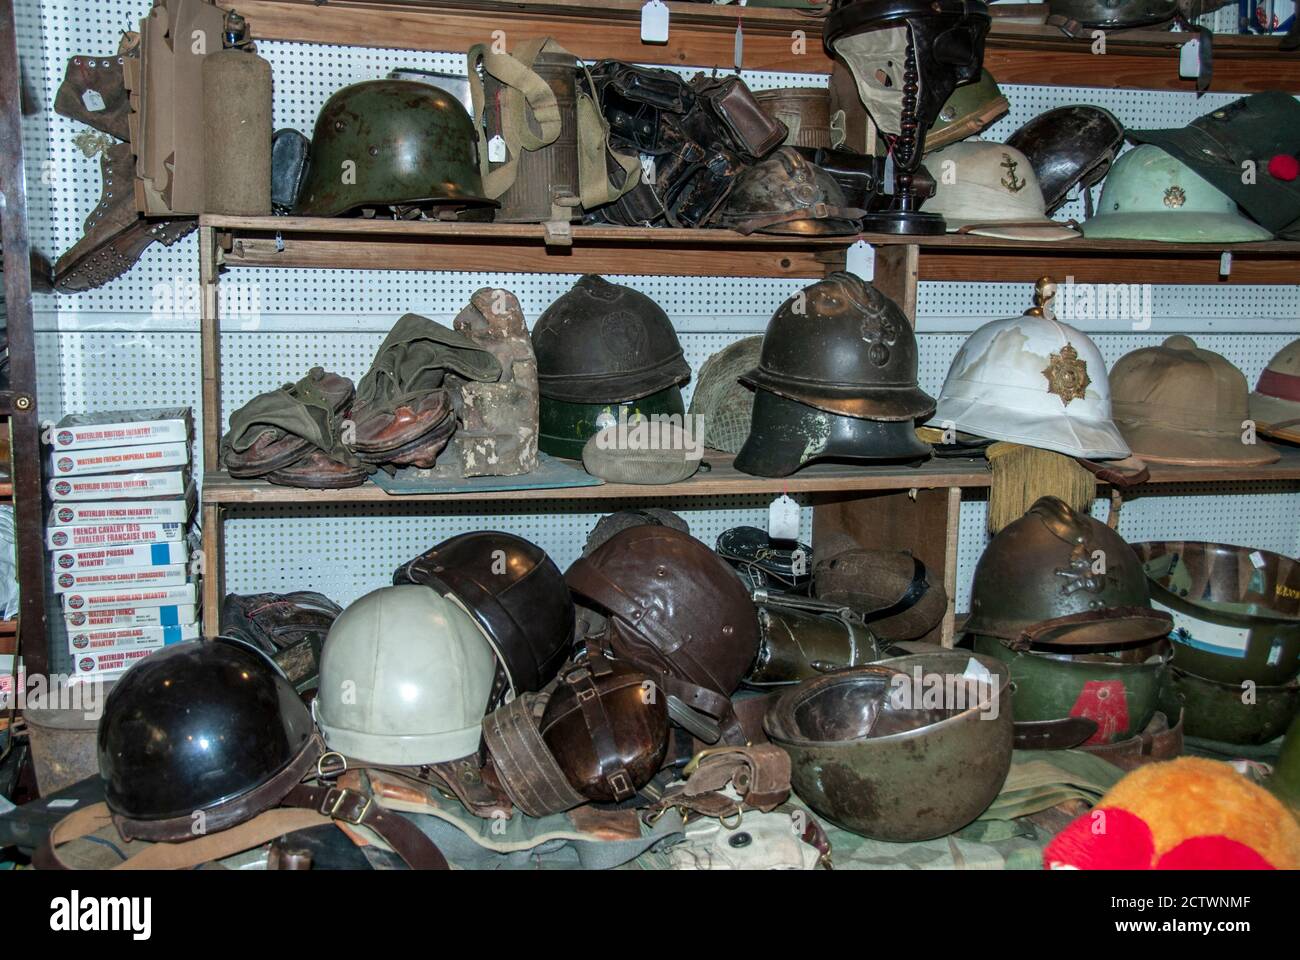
<box><xmin>221</xmin><ymin>0</ymin><xmax>1300</xmax><ymax>92</ymax></box>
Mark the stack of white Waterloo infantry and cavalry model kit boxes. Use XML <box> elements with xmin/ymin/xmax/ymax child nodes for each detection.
<box><xmin>46</xmin><ymin>407</ymin><xmax>199</xmax><ymax>679</ymax></box>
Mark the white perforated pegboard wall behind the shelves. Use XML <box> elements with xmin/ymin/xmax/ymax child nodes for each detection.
<box><xmin>17</xmin><ymin>0</ymin><xmax>1300</xmax><ymax>606</ymax></box>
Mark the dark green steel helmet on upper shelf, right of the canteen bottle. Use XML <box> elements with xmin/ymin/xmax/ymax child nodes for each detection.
<box><xmin>294</xmin><ymin>79</ymin><xmax>498</xmax><ymax>217</ymax></box>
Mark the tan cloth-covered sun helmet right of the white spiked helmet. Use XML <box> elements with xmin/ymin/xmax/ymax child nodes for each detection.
<box><xmin>1110</xmin><ymin>336</ymin><xmax>1281</xmax><ymax>466</ymax></box>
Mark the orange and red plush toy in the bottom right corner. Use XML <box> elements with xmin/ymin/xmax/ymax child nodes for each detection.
<box><xmin>1043</xmin><ymin>757</ymin><xmax>1300</xmax><ymax>870</ymax></box>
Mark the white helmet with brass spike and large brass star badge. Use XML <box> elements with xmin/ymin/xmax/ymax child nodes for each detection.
<box><xmin>931</xmin><ymin>284</ymin><xmax>1130</xmax><ymax>459</ymax></box>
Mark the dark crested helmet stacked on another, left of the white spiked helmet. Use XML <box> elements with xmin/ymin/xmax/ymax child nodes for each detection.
<box><xmin>741</xmin><ymin>273</ymin><xmax>935</xmax><ymax>421</ymax></box>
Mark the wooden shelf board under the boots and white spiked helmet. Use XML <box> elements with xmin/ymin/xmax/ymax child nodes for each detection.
<box><xmin>203</xmin><ymin>447</ymin><xmax>1300</xmax><ymax>506</ymax></box>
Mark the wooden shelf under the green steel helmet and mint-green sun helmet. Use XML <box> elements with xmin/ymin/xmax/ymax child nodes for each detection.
<box><xmin>200</xmin><ymin>215</ymin><xmax>1300</xmax><ymax>284</ymax></box>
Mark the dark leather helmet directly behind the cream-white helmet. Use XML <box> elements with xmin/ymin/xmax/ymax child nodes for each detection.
<box><xmin>393</xmin><ymin>531</ymin><xmax>573</xmax><ymax>704</ymax></box>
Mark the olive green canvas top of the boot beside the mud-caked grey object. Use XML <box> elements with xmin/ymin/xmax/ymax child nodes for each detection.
<box><xmin>356</xmin><ymin>313</ymin><xmax>501</xmax><ymax>412</ymax></box>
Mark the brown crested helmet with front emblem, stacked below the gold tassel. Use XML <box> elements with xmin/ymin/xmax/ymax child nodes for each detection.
<box><xmin>965</xmin><ymin>497</ymin><xmax>1173</xmax><ymax>649</ymax></box>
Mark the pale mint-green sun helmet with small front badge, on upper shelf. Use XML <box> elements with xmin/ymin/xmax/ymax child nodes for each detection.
<box><xmin>1083</xmin><ymin>143</ymin><xmax>1273</xmax><ymax>243</ymax></box>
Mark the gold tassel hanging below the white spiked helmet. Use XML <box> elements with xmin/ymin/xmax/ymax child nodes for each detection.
<box><xmin>985</xmin><ymin>442</ymin><xmax>1097</xmax><ymax>533</ymax></box>
